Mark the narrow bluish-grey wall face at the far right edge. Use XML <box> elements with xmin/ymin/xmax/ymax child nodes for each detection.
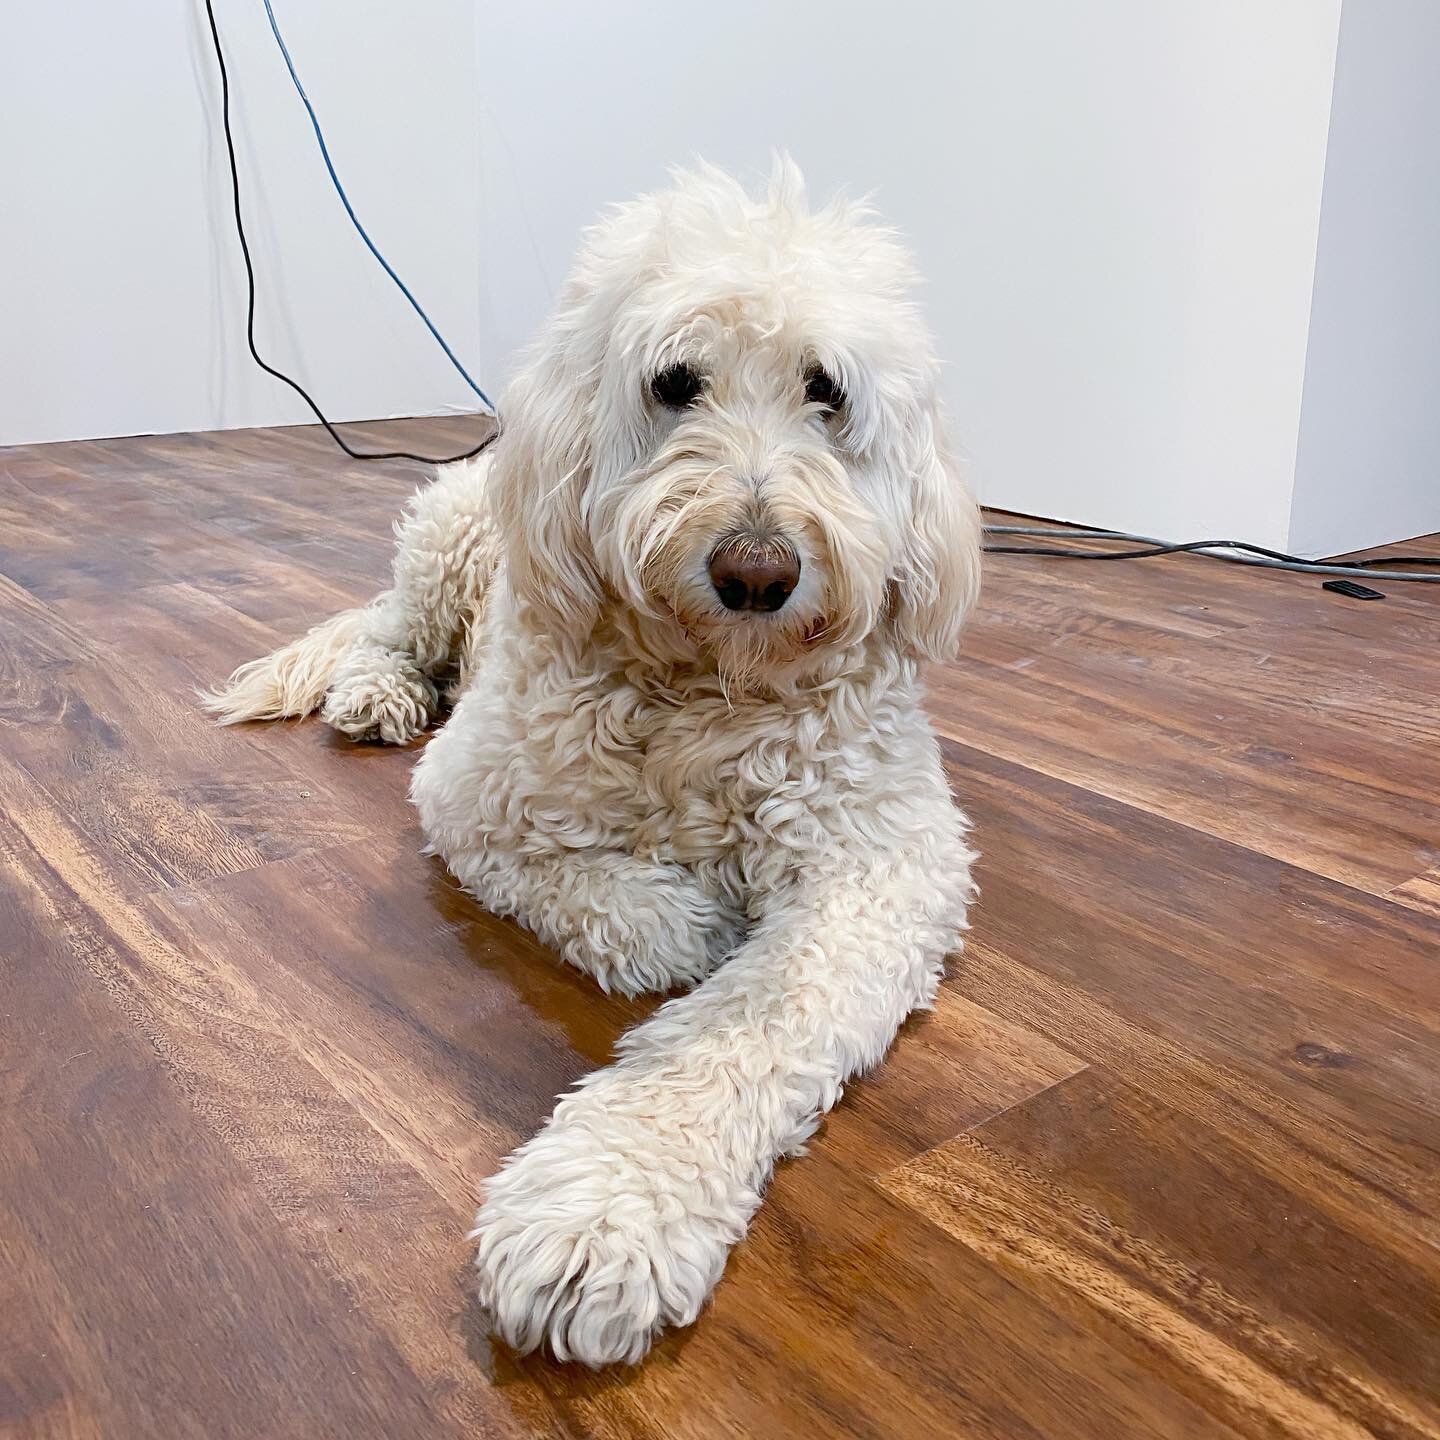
<box><xmin>1290</xmin><ymin>0</ymin><xmax>1440</xmax><ymax>554</ymax></box>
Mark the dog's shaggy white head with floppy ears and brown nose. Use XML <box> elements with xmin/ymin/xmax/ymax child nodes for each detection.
<box><xmin>495</xmin><ymin>160</ymin><xmax>979</xmax><ymax>683</ymax></box>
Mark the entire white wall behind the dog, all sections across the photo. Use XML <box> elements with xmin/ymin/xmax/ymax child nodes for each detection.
<box><xmin>8</xmin><ymin>0</ymin><xmax>1440</xmax><ymax>552</ymax></box>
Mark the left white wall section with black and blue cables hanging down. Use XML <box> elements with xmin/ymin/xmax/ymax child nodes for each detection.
<box><xmin>0</xmin><ymin>0</ymin><xmax>484</xmax><ymax>444</ymax></box>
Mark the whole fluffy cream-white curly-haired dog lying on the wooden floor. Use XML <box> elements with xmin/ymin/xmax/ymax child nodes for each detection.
<box><xmin>210</xmin><ymin>161</ymin><xmax>979</xmax><ymax>1365</ymax></box>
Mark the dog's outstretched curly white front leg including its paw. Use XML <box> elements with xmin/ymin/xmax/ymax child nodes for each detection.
<box><xmin>475</xmin><ymin>845</ymin><xmax>969</xmax><ymax>1365</ymax></box>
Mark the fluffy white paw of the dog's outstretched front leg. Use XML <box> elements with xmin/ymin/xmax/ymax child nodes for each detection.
<box><xmin>471</xmin><ymin>1125</ymin><xmax>753</xmax><ymax>1365</ymax></box>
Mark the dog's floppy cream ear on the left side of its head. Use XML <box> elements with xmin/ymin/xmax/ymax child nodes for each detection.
<box><xmin>491</xmin><ymin>329</ymin><xmax>600</xmax><ymax>635</ymax></box>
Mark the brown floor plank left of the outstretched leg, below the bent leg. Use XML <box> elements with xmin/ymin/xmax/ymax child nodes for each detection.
<box><xmin>150</xmin><ymin>832</ymin><xmax>622</xmax><ymax>1209</ymax></box>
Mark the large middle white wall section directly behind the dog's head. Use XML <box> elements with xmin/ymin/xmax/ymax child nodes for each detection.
<box><xmin>478</xmin><ymin>0</ymin><xmax>1339</xmax><ymax>544</ymax></box>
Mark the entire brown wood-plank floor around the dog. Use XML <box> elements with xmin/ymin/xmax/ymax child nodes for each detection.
<box><xmin>0</xmin><ymin>411</ymin><xmax>1440</xmax><ymax>1440</ymax></box>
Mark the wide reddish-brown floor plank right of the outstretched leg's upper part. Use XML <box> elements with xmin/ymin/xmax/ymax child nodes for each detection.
<box><xmin>950</xmin><ymin>747</ymin><xmax>1440</xmax><ymax>1244</ymax></box>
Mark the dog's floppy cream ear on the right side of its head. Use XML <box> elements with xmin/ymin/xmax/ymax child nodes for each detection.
<box><xmin>893</xmin><ymin>399</ymin><xmax>981</xmax><ymax>661</ymax></box>
